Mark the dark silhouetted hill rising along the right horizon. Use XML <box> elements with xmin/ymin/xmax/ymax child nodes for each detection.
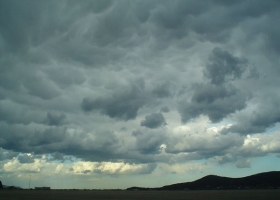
<box><xmin>128</xmin><ymin>171</ymin><xmax>280</xmax><ymax>190</ymax></box>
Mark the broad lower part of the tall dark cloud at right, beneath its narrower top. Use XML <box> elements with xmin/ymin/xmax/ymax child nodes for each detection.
<box><xmin>178</xmin><ymin>84</ymin><xmax>247</xmax><ymax>123</ymax></box>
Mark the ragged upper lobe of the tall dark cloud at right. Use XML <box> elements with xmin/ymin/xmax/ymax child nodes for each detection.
<box><xmin>204</xmin><ymin>47</ymin><xmax>248</xmax><ymax>85</ymax></box>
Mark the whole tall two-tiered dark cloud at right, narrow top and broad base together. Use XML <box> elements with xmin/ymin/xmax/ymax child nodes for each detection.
<box><xmin>179</xmin><ymin>47</ymin><xmax>252</xmax><ymax>123</ymax></box>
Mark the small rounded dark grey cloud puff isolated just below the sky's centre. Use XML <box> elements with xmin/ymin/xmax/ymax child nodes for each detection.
<box><xmin>141</xmin><ymin>113</ymin><xmax>167</xmax><ymax>129</ymax></box>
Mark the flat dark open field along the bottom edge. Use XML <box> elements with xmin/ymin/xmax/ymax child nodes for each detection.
<box><xmin>0</xmin><ymin>190</ymin><xmax>280</xmax><ymax>200</ymax></box>
